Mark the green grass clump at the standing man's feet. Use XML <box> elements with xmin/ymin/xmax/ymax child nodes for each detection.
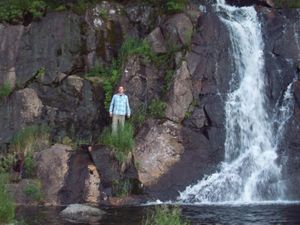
<box><xmin>99</xmin><ymin>122</ymin><xmax>134</xmax><ymax>162</ymax></box>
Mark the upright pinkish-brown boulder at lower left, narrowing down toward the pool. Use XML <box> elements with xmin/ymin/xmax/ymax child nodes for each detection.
<box><xmin>36</xmin><ymin>144</ymin><xmax>72</xmax><ymax>205</ymax></box>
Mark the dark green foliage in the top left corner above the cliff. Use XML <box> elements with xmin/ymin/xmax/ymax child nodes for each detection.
<box><xmin>0</xmin><ymin>0</ymin><xmax>46</xmax><ymax>23</ymax></box>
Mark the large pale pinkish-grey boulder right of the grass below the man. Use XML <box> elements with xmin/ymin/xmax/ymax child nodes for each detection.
<box><xmin>133</xmin><ymin>121</ymin><xmax>184</xmax><ymax>187</ymax></box>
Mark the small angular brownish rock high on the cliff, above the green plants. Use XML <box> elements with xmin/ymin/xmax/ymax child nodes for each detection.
<box><xmin>147</xmin><ymin>27</ymin><xmax>167</xmax><ymax>53</ymax></box>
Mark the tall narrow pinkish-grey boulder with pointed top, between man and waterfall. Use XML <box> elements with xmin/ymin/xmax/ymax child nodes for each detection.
<box><xmin>166</xmin><ymin>61</ymin><xmax>193</xmax><ymax>122</ymax></box>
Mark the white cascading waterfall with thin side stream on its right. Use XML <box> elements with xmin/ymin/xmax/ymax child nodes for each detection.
<box><xmin>179</xmin><ymin>0</ymin><xmax>291</xmax><ymax>202</ymax></box>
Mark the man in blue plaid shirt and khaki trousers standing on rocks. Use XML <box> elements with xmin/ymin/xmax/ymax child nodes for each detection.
<box><xmin>109</xmin><ymin>86</ymin><xmax>131</xmax><ymax>134</ymax></box>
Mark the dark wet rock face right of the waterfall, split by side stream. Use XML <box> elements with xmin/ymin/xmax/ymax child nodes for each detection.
<box><xmin>259</xmin><ymin>9</ymin><xmax>300</xmax><ymax>199</ymax></box>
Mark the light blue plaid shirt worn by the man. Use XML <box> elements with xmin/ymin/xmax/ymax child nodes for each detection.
<box><xmin>109</xmin><ymin>94</ymin><xmax>131</xmax><ymax>116</ymax></box>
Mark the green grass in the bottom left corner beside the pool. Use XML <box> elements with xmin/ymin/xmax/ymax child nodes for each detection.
<box><xmin>0</xmin><ymin>174</ymin><xmax>15</xmax><ymax>224</ymax></box>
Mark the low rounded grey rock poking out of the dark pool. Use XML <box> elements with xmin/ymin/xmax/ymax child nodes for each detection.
<box><xmin>60</xmin><ymin>204</ymin><xmax>105</xmax><ymax>223</ymax></box>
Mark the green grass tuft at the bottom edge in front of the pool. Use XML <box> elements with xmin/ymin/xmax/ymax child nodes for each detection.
<box><xmin>143</xmin><ymin>206</ymin><xmax>190</xmax><ymax>225</ymax></box>
